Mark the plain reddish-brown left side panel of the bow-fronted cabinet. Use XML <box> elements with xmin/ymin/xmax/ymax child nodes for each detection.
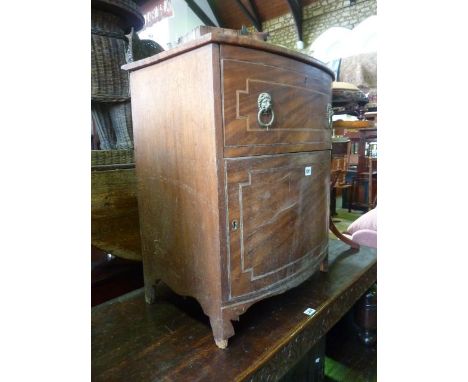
<box><xmin>131</xmin><ymin>44</ymin><xmax>221</xmax><ymax>314</ymax></box>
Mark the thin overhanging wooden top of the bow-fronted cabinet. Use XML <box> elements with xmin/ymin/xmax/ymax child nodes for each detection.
<box><xmin>122</xmin><ymin>28</ymin><xmax>335</xmax><ymax>80</ymax></box>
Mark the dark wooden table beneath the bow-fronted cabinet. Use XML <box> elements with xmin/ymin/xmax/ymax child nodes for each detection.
<box><xmin>92</xmin><ymin>240</ymin><xmax>377</xmax><ymax>381</ymax></box>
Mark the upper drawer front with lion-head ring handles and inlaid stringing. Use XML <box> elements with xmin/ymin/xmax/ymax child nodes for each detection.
<box><xmin>221</xmin><ymin>46</ymin><xmax>331</xmax><ymax>157</ymax></box>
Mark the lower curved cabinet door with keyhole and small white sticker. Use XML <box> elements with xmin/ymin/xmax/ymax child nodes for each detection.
<box><xmin>225</xmin><ymin>151</ymin><xmax>330</xmax><ymax>301</ymax></box>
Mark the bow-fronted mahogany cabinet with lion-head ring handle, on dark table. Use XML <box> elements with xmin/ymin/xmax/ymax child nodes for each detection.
<box><xmin>125</xmin><ymin>31</ymin><xmax>333</xmax><ymax>347</ymax></box>
